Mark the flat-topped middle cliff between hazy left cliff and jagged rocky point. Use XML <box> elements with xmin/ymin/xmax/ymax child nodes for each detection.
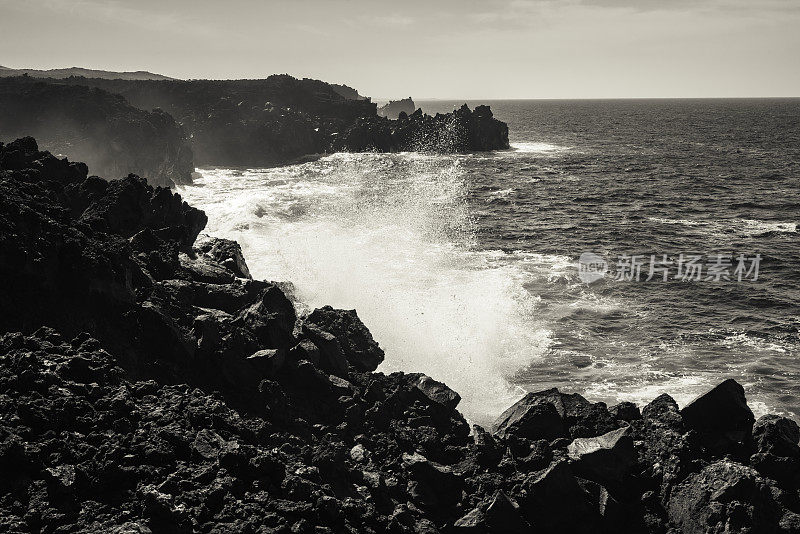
<box><xmin>34</xmin><ymin>74</ymin><xmax>375</xmax><ymax>166</ymax></box>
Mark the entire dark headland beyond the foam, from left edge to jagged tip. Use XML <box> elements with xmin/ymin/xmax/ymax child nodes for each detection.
<box><xmin>0</xmin><ymin>74</ymin><xmax>509</xmax><ymax>174</ymax></box>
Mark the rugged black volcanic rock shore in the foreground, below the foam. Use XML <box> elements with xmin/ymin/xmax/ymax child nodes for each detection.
<box><xmin>0</xmin><ymin>136</ymin><xmax>800</xmax><ymax>533</ymax></box>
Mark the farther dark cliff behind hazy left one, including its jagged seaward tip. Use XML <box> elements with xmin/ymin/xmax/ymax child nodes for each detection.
<box><xmin>28</xmin><ymin>74</ymin><xmax>508</xmax><ymax>166</ymax></box>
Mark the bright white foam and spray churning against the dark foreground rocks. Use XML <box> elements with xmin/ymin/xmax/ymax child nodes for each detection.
<box><xmin>181</xmin><ymin>154</ymin><xmax>549</xmax><ymax>424</ymax></box>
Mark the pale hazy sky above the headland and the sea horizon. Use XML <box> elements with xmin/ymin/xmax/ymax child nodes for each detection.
<box><xmin>0</xmin><ymin>0</ymin><xmax>800</xmax><ymax>99</ymax></box>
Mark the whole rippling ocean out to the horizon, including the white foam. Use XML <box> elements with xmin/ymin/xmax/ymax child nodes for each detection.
<box><xmin>179</xmin><ymin>99</ymin><xmax>800</xmax><ymax>424</ymax></box>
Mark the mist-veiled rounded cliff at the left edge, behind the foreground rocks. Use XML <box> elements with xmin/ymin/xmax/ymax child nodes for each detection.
<box><xmin>0</xmin><ymin>77</ymin><xmax>194</xmax><ymax>185</ymax></box>
